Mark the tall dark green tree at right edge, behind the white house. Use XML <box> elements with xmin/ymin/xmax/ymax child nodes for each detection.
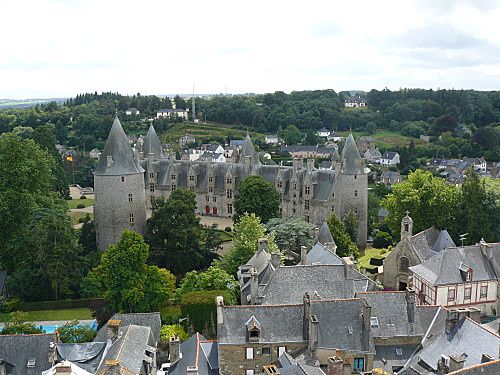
<box><xmin>457</xmin><ymin>168</ymin><xmax>500</xmax><ymax>244</ymax></box>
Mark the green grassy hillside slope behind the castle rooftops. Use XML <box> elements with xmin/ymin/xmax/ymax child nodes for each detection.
<box><xmin>161</xmin><ymin>121</ymin><xmax>264</xmax><ymax>145</ymax></box>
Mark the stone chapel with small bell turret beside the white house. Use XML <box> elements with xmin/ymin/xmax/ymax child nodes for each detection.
<box><xmin>383</xmin><ymin>213</ymin><xmax>455</xmax><ymax>290</ymax></box>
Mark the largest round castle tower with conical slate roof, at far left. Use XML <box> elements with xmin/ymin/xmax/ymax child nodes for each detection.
<box><xmin>94</xmin><ymin>117</ymin><xmax>146</xmax><ymax>251</ymax></box>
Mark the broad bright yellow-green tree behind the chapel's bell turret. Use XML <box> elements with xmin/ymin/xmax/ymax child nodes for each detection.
<box><xmin>381</xmin><ymin>169</ymin><xmax>459</xmax><ymax>238</ymax></box>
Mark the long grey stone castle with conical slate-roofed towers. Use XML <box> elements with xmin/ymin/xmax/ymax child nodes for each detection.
<box><xmin>94</xmin><ymin>118</ymin><xmax>369</xmax><ymax>250</ymax></box>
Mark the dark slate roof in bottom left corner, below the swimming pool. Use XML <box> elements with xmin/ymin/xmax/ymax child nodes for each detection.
<box><xmin>0</xmin><ymin>333</ymin><xmax>56</xmax><ymax>375</ymax></box>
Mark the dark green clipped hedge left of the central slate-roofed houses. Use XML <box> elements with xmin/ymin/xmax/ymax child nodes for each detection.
<box><xmin>181</xmin><ymin>290</ymin><xmax>236</xmax><ymax>339</ymax></box>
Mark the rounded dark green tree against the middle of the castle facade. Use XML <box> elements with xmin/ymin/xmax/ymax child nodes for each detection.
<box><xmin>234</xmin><ymin>176</ymin><xmax>280</xmax><ymax>223</ymax></box>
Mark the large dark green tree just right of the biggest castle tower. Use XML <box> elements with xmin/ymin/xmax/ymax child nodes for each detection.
<box><xmin>145</xmin><ymin>189</ymin><xmax>218</xmax><ymax>276</ymax></box>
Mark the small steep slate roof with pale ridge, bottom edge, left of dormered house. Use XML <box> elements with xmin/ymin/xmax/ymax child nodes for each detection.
<box><xmin>168</xmin><ymin>333</ymin><xmax>219</xmax><ymax>375</ymax></box>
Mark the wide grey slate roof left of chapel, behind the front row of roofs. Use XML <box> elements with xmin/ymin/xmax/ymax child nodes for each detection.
<box><xmin>262</xmin><ymin>264</ymin><xmax>373</xmax><ymax>304</ymax></box>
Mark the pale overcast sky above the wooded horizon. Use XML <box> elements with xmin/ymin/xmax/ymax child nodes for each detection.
<box><xmin>0</xmin><ymin>0</ymin><xmax>500</xmax><ymax>99</ymax></box>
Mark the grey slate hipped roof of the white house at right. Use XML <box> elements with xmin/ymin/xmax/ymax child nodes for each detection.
<box><xmin>410</xmin><ymin>245</ymin><xmax>500</xmax><ymax>285</ymax></box>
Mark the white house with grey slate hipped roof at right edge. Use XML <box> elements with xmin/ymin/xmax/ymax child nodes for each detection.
<box><xmin>410</xmin><ymin>241</ymin><xmax>500</xmax><ymax>315</ymax></box>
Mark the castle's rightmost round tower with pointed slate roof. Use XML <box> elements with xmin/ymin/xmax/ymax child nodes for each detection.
<box><xmin>334</xmin><ymin>133</ymin><xmax>370</xmax><ymax>248</ymax></box>
